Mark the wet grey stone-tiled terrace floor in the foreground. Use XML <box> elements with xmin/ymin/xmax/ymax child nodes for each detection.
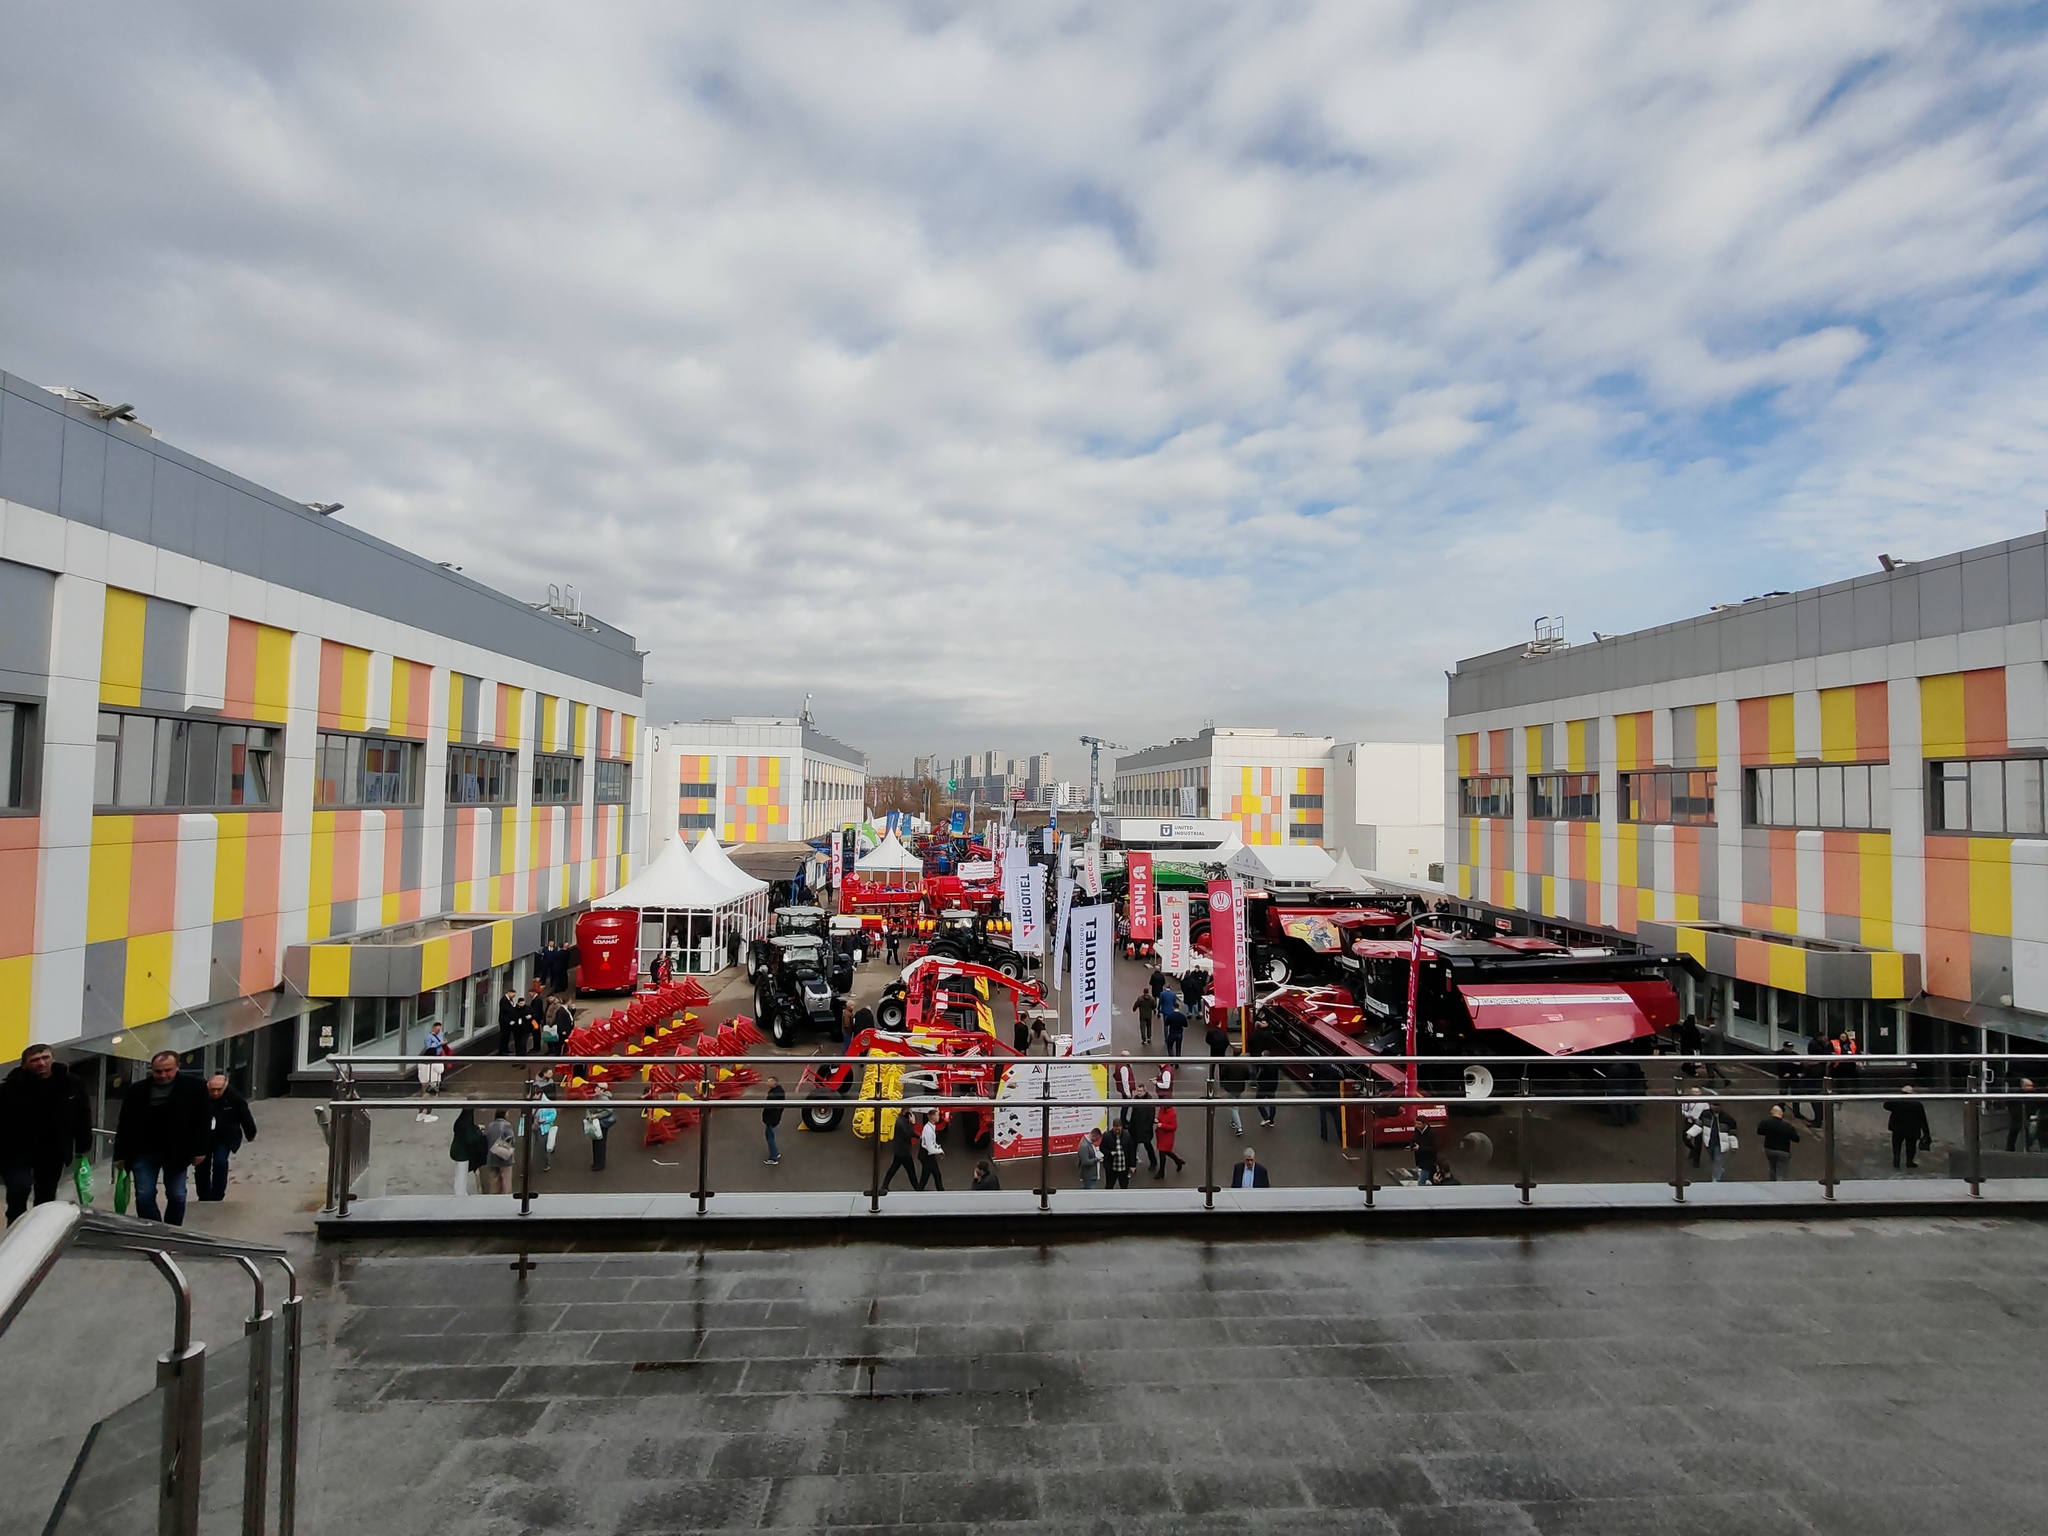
<box><xmin>307</xmin><ymin>1219</ymin><xmax>2048</xmax><ymax>1536</ymax></box>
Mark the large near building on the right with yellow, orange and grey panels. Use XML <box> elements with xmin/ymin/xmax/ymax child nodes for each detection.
<box><xmin>1444</xmin><ymin>535</ymin><xmax>2048</xmax><ymax>1051</ymax></box>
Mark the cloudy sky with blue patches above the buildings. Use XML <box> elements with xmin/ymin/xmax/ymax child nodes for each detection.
<box><xmin>0</xmin><ymin>0</ymin><xmax>2048</xmax><ymax>774</ymax></box>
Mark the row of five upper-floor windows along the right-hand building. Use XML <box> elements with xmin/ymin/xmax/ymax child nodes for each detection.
<box><xmin>1458</xmin><ymin>758</ymin><xmax>2048</xmax><ymax>838</ymax></box>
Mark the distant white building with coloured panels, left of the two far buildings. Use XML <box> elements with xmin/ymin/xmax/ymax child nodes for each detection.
<box><xmin>649</xmin><ymin>715</ymin><xmax>868</xmax><ymax>856</ymax></box>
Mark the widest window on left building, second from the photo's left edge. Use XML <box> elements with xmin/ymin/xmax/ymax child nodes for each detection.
<box><xmin>92</xmin><ymin>709</ymin><xmax>285</xmax><ymax>811</ymax></box>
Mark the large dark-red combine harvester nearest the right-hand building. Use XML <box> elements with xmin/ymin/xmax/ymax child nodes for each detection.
<box><xmin>1352</xmin><ymin>924</ymin><xmax>1700</xmax><ymax>1100</ymax></box>
